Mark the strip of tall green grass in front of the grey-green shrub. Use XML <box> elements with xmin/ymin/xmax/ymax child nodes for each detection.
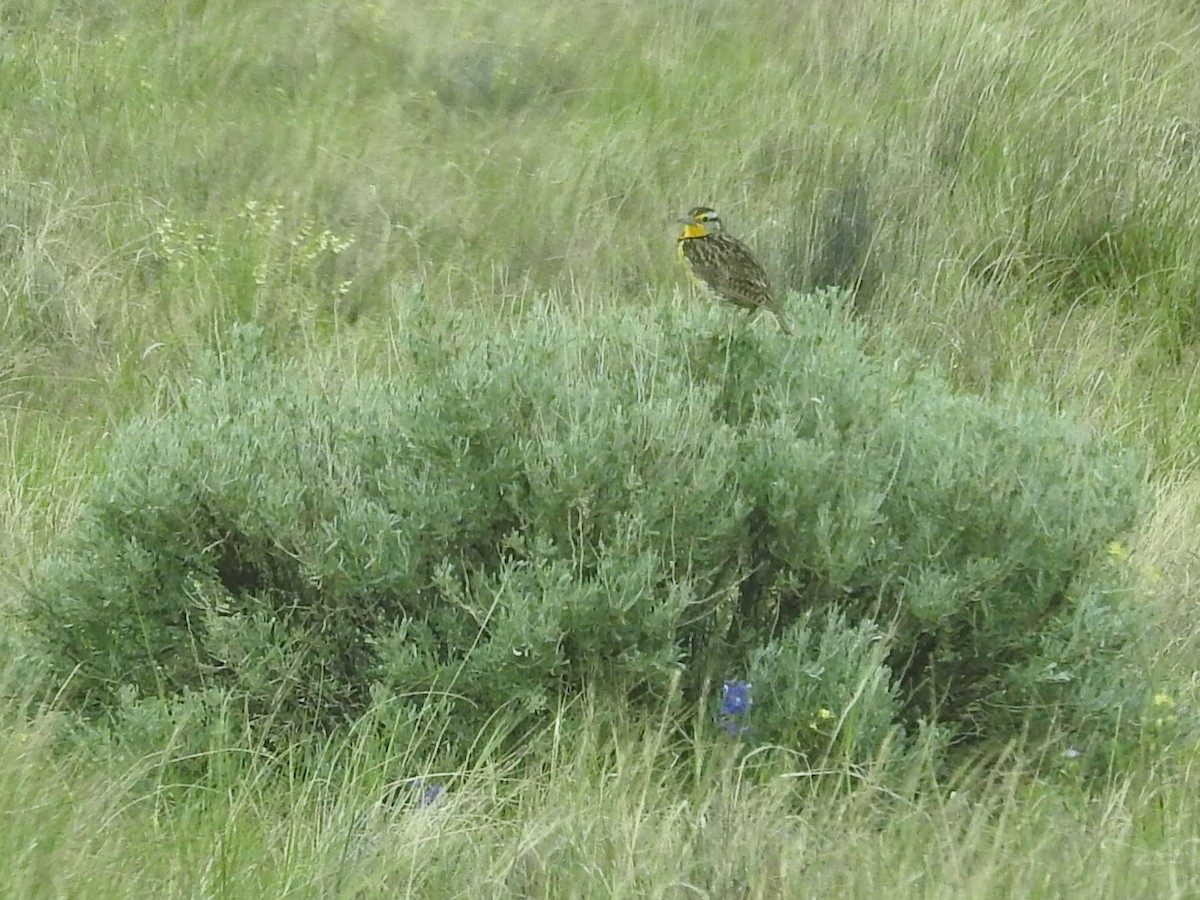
<box><xmin>0</xmin><ymin>696</ymin><xmax>1200</xmax><ymax>898</ymax></box>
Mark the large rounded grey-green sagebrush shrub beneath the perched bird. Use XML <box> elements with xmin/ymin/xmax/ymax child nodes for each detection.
<box><xmin>26</xmin><ymin>296</ymin><xmax>1146</xmax><ymax>754</ymax></box>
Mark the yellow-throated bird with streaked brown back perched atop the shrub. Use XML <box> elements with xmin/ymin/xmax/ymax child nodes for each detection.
<box><xmin>679</xmin><ymin>206</ymin><xmax>792</xmax><ymax>335</ymax></box>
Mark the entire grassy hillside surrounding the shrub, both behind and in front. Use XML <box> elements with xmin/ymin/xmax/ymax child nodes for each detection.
<box><xmin>0</xmin><ymin>0</ymin><xmax>1200</xmax><ymax>898</ymax></box>
